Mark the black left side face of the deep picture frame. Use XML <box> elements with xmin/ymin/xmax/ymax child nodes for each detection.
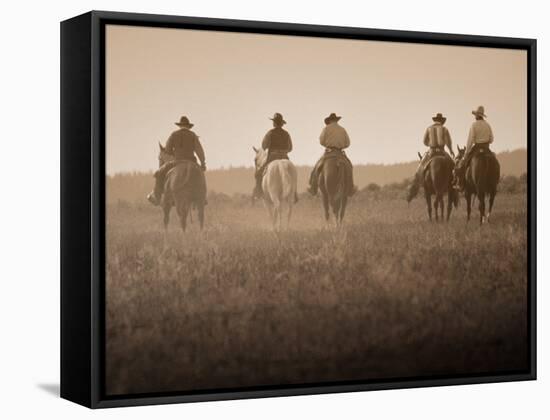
<box><xmin>60</xmin><ymin>13</ymin><xmax>93</xmax><ymax>407</ymax></box>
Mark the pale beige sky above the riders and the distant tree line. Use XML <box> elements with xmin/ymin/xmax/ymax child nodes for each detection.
<box><xmin>105</xmin><ymin>25</ymin><xmax>527</xmax><ymax>175</ymax></box>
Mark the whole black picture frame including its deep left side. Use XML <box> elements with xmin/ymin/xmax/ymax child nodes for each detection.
<box><xmin>61</xmin><ymin>11</ymin><xmax>536</xmax><ymax>408</ymax></box>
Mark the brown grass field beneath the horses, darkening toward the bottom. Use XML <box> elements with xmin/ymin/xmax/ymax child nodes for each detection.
<box><xmin>106</xmin><ymin>193</ymin><xmax>528</xmax><ymax>394</ymax></box>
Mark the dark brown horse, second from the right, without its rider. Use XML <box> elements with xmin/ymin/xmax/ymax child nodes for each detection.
<box><xmin>418</xmin><ymin>153</ymin><xmax>458</xmax><ymax>222</ymax></box>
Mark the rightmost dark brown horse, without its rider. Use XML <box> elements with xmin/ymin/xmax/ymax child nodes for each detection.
<box><xmin>458</xmin><ymin>147</ymin><xmax>500</xmax><ymax>225</ymax></box>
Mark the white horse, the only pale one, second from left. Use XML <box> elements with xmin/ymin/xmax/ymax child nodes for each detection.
<box><xmin>253</xmin><ymin>147</ymin><xmax>298</xmax><ymax>232</ymax></box>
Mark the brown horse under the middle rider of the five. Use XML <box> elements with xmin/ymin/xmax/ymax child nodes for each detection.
<box><xmin>318</xmin><ymin>152</ymin><xmax>353</xmax><ymax>226</ymax></box>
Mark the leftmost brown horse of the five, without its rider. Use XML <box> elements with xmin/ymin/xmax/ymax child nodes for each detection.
<box><xmin>159</xmin><ymin>143</ymin><xmax>206</xmax><ymax>232</ymax></box>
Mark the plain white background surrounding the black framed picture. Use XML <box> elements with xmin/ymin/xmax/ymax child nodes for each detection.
<box><xmin>0</xmin><ymin>0</ymin><xmax>550</xmax><ymax>420</ymax></box>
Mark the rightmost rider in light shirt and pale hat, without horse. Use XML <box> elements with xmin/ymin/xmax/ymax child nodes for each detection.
<box><xmin>454</xmin><ymin>105</ymin><xmax>494</xmax><ymax>191</ymax></box>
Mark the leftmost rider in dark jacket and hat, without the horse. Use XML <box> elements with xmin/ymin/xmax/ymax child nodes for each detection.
<box><xmin>147</xmin><ymin>116</ymin><xmax>206</xmax><ymax>206</ymax></box>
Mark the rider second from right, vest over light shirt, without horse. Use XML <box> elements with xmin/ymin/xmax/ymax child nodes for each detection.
<box><xmin>408</xmin><ymin>112</ymin><xmax>455</xmax><ymax>201</ymax></box>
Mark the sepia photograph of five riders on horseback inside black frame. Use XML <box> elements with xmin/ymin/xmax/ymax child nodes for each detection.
<box><xmin>104</xmin><ymin>24</ymin><xmax>531</xmax><ymax>397</ymax></box>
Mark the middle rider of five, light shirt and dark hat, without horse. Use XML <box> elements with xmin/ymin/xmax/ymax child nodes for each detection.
<box><xmin>308</xmin><ymin>112</ymin><xmax>357</xmax><ymax>196</ymax></box>
